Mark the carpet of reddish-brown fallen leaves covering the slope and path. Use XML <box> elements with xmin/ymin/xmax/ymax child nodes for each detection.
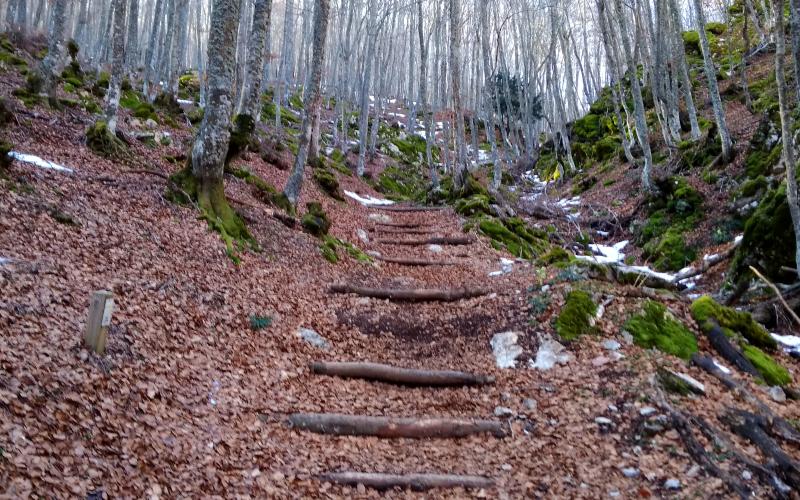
<box><xmin>0</xmin><ymin>50</ymin><xmax>800</xmax><ymax>498</ymax></box>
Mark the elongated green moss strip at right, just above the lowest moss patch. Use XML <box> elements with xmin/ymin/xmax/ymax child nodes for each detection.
<box><xmin>691</xmin><ymin>295</ymin><xmax>777</xmax><ymax>350</ymax></box>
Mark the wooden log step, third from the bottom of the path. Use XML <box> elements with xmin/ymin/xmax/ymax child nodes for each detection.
<box><xmin>311</xmin><ymin>362</ymin><xmax>494</xmax><ymax>387</ymax></box>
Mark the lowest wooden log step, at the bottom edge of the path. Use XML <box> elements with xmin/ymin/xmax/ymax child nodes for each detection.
<box><xmin>318</xmin><ymin>472</ymin><xmax>494</xmax><ymax>491</ymax></box>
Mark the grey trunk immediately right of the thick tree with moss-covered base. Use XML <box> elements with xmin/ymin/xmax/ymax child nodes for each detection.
<box><xmin>239</xmin><ymin>0</ymin><xmax>272</xmax><ymax>122</ymax></box>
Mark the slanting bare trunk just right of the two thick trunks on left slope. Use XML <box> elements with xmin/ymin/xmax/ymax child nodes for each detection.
<box><xmin>283</xmin><ymin>0</ymin><xmax>330</xmax><ymax>206</ymax></box>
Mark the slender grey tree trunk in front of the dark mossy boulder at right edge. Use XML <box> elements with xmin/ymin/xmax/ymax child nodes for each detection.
<box><xmin>775</xmin><ymin>0</ymin><xmax>800</xmax><ymax>277</ymax></box>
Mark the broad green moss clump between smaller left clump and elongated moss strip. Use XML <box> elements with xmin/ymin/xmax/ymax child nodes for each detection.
<box><xmin>623</xmin><ymin>300</ymin><xmax>697</xmax><ymax>359</ymax></box>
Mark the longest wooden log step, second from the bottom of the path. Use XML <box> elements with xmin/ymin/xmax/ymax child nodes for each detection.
<box><xmin>289</xmin><ymin>413</ymin><xmax>508</xmax><ymax>439</ymax></box>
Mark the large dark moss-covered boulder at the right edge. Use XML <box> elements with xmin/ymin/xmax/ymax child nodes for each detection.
<box><xmin>731</xmin><ymin>183</ymin><xmax>796</xmax><ymax>281</ymax></box>
